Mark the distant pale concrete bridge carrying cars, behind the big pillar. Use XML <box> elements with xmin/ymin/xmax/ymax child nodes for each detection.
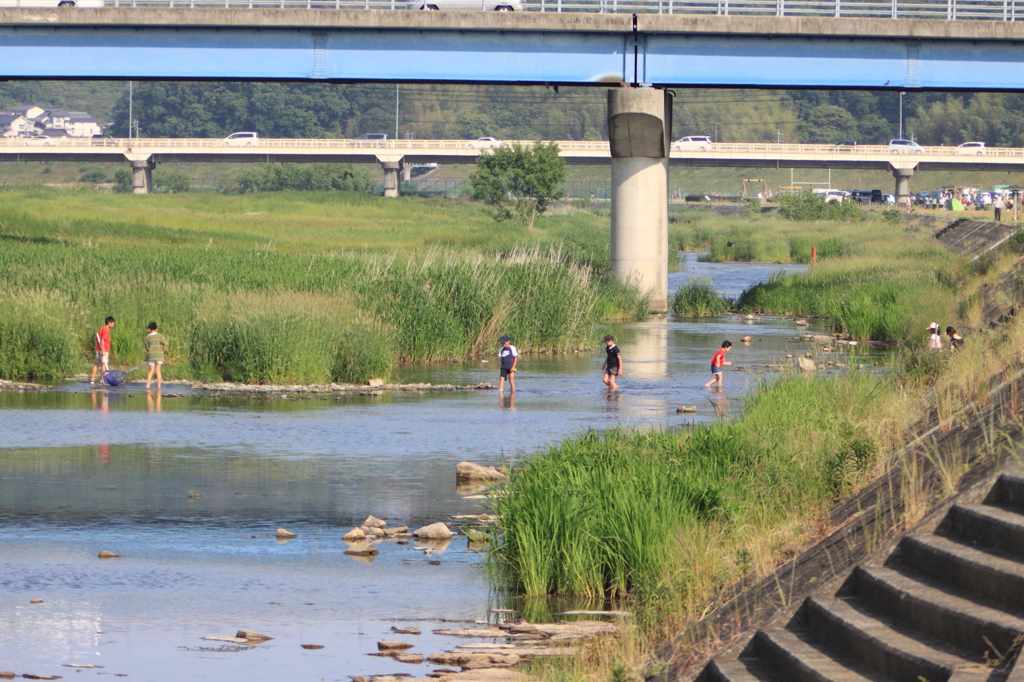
<box><xmin>6</xmin><ymin>137</ymin><xmax>1024</xmax><ymax>191</ymax></box>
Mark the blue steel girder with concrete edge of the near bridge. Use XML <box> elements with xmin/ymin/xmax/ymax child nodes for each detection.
<box><xmin>0</xmin><ymin>8</ymin><xmax>1024</xmax><ymax>90</ymax></box>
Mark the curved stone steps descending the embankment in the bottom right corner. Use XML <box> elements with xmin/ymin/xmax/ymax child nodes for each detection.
<box><xmin>695</xmin><ymin>466</ymin><xmax>1024</xmax><ymax>682</ymax></box>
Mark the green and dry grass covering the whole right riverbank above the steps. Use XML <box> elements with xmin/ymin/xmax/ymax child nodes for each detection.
<box><xmin>492</xmin><ymin>206</ymin><xmax>1024</xmax><ymax>680</ymax></box>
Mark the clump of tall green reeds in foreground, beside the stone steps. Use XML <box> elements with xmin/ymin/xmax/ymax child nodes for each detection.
<box><xmin>493</xmin><ymin>374</ymin><xmax>899</xmax><ymax>610</ymax></box>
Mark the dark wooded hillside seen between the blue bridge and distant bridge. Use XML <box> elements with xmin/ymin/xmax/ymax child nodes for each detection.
<box><xmin>0</xmin><ymin>81</ymin><xmax>1024</xmax><ymax>146</ymax></box>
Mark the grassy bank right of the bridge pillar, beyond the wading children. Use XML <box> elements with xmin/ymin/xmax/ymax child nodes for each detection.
<box><xmin>672</xmin><ymin>206</ymin><xmax>962</xmax><ymax>342</ymax></box>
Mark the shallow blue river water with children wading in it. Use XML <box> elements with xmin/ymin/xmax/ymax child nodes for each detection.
<box><xmin>0</xmin><ymin>254</ymin><xmax>868</xmax><ymax>681</ymax></box>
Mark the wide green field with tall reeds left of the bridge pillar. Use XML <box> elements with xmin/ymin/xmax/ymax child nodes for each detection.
<box><xmin>0</xmin><ymin>187</ymin><xmax>646</xmax><ymax>383</ymax></box>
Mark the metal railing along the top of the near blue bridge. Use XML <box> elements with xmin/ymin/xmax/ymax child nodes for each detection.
<box><xmin>92</xmin><ymin>0</ymin><xmax>1024</xmax><ymax>22</ymax></box>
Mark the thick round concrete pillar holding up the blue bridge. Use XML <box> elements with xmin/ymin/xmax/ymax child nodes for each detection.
<box><xmin>608</xmin><ymin>87</ymin><xmax>672</xmax><ymax>312</ymax></box>
